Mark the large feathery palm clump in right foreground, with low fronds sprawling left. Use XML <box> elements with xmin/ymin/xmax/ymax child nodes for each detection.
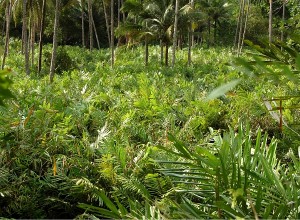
<box><xmin>75</xmin><ymin>122</ymin><xmax>300</xmax><ymax>219</ymax></box>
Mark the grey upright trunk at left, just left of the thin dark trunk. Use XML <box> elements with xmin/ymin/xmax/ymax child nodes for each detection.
<box><xmin>22</xmin><ymin>0</ymin><xmax>30</xmax><ymax>75</ymax></box>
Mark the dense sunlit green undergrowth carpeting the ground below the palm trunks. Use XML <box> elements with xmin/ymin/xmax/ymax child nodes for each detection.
<box><xmin>0</xmin><ymin>41</ymin><xmax>300</xmax><ymax>219</ymax></box>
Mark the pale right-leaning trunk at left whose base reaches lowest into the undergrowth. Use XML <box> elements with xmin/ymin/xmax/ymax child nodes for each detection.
<box><xmin>50</xmin><ymin>0</ymin><xmax>61</xmax><ymax>83</ymax></box>
